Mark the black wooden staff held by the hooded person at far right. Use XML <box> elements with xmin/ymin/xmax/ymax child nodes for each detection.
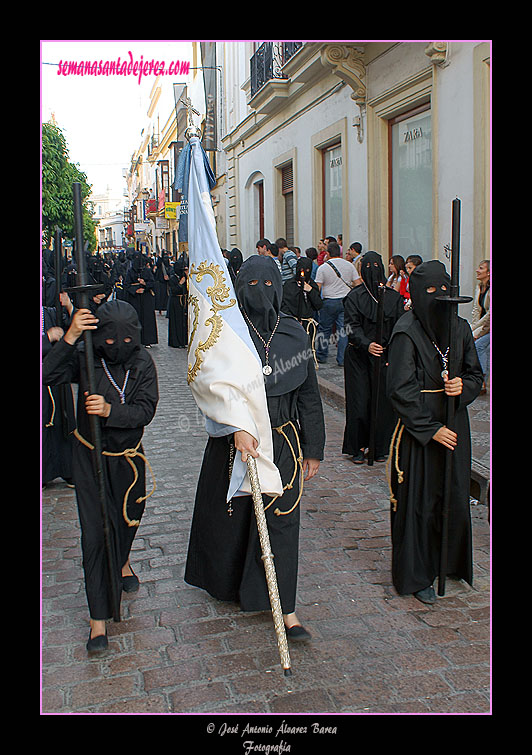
<box><xmin>437</xmin><ymin>198</ymin><xmax>472</xmax><ymax>595</ymax></box>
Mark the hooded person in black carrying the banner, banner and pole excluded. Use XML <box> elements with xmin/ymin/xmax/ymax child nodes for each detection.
<box><xmin>185</xmin><ymin>255</ymin><xmax>325</xmax><ymax>640</ymax></box>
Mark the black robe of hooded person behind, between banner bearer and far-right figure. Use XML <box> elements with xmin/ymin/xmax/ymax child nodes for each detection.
<box><xmin>342</xmin><ymin>252</ymin><xmax>404</xmax><ymax>458</ymax></box>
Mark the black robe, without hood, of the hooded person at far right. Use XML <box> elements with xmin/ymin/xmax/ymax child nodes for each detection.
<box><xmin>387</xmin><ymin>302</ymin><xmax>482</xmax><ymax>595</ymax></box>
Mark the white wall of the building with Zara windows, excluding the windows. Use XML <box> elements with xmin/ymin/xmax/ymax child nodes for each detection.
<box><xmin>220</xmin><ymin>41</ymin><xmax>490</xmax><ymax>295</ymax></box>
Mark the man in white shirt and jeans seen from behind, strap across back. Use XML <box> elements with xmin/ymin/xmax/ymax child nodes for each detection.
<box><xmin>316</xmin><ymin>241</ymin><xmax>361</xmax><ymax>366</ymax></box>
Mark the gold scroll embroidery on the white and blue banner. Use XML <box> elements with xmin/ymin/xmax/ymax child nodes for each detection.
<box><xmin>187</xmin><ymin>260</ymin><xmax>236</xmax><ymax>384</ymax></box>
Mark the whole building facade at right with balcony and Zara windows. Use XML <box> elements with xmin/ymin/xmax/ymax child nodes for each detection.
<box><xmin>213</xmin><ymin>41</ymin><xmax>491</xmax><ymax>300</ymax></box>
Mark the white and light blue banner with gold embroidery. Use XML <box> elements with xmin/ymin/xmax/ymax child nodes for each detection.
<box><xmin>181</xmin><ymin>137</ymin><xmax>283</xmax><ymax>500</ymax></box>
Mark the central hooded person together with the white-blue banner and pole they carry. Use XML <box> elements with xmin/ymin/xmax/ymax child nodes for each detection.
<box><xmin>176</xmin><ymin>134</ymin><xmax>325</xmax><ymax>656</ymax></box>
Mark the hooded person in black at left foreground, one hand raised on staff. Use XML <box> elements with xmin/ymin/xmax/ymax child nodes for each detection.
<box><xmin>43</xmin><ymin>300</ymin><xmax>158</xmax><ymax>652</ymax></box>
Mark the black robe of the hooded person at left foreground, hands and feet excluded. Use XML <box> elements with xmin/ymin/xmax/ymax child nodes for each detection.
<box><xmin>43</xmin><ymin>301</ymin><xmax>159</xmax><ymax>620</ymax></box>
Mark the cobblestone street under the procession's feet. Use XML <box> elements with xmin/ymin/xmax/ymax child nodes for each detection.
<box><xmin>41</xmin><ymin>315</ymin><xmax>490</xmax><ymax>715</ymax></box>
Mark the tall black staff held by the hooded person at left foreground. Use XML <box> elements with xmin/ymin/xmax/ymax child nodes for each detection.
<box><xmin>69</xmin><ymin>181</ymin><xmax>120</xmax><ymax>621</ymax></box>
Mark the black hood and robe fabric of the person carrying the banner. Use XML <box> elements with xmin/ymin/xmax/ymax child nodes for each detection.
<box><xmin>185</xmin><ymin>255</ymin><xmax>325</xmax><ymax>614</ymax></box>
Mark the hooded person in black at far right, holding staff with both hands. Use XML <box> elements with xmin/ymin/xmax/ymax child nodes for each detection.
<box><xmin>387</xmin><ymin>260</ymin><xmax>482</xmax><ymax>604</ymax></box>
